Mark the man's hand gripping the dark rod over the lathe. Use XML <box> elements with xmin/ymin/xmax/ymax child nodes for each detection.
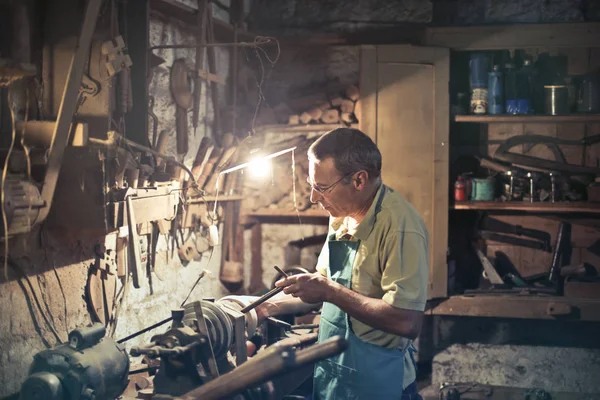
<box><xmin>275</xmin><ymin>273</ymin><xmax>336</xmax><ymax>304</ymax></box>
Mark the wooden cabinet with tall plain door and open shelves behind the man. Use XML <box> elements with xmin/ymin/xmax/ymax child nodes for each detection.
<box><xmin>360</xmin><ymin>23</ymin><xmax>600</xmax><ymax>321</ymax></box>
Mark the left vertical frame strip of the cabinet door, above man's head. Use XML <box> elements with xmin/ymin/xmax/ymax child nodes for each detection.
<box><xmin>358</xmin><ymin>46</ymin><xmax>377</xmax><ymax>143</ymax></box>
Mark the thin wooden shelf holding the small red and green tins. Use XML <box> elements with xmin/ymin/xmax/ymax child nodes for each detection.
<box><xmin>450</xmin><ymin>201</ymin><xmax>600</xmax><ymax>214</ymax></box>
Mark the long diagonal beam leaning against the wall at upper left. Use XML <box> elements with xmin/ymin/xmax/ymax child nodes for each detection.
<box><xmin>36</xmin><ymin>0</ymin><xmax>103</xmax><ymax>222</ymax></box>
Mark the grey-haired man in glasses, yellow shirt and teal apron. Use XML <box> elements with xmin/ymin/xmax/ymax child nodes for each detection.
<box><xmin>259</xmin><ymin>128</ymin><xmax>429</xmax><ymax>400</ymax></box>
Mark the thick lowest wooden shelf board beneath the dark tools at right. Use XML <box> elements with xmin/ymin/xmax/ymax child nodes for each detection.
<box><xmin>427</xmin><ymin>294</ymin><xmax>600</xmax><ymax>321</ymax></box>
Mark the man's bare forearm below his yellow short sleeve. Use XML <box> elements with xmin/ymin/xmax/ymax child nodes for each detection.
<box><xmin>328</xmin><ymin>284</ymin><xmax>423</xmax><ymax>339</ymax></box>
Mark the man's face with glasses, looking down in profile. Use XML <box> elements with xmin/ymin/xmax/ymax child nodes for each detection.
<box><xmin>308</xmin><ymin>158</ymin><xmax>355</xmax><ymax>217</ymax></box>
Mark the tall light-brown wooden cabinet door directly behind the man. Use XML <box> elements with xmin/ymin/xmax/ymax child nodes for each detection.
<box><xmin>360</xmin><ymin>45</ymin><xmax>450</xmax><ymax>299</ymax></box>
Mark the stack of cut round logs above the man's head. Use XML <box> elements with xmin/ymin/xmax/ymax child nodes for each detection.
<box><xmin>257</xmin><ymin>85</ymin><xmax>360</xmax><ymax>126</ymax></box>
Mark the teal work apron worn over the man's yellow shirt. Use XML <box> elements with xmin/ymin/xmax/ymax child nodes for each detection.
<box><xmin>313</xmin><ymin>238</ymin><xmax>406</xmax><ymax>400</ymax></box>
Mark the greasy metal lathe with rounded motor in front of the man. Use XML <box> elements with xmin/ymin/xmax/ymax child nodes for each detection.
<box><xmin>20</xmin><ymin>296</ymin><xmax>340</xmax><ymax>400</ymax></box>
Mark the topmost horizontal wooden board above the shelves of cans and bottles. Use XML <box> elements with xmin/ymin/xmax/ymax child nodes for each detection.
<box><xmin>425</xmin><ymin>22</ymin><xmax>600</xmax><ymax>50</ymax></box>
